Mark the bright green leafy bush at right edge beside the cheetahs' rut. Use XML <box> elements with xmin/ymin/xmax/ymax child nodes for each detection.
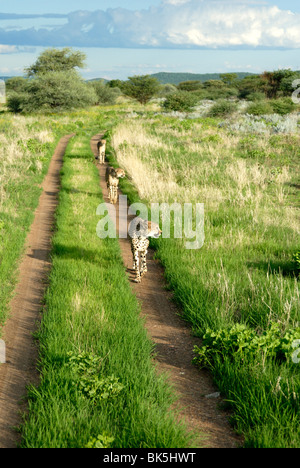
<box><xmin>193</xmin><ymin>323</ymin><xmax>300</xmax><ymax>368</ymax></box>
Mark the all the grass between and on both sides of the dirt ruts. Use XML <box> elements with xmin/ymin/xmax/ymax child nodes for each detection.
<box><xmin>0</xmin><ymin>103</ymin><xmax>300</xmax><ymax>448</ymax></box>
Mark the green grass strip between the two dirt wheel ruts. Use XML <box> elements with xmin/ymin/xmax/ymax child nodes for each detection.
<box><xmin>21</xmin><ymin>127</ymin><xmax>190</xmax><ymax>448</ymax></box>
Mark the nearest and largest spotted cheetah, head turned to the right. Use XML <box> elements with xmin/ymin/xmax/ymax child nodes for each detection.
<box><xmin>129</xmin><ymin>218</ymin><xmax>162</xmax><ymax>283</ymax></box>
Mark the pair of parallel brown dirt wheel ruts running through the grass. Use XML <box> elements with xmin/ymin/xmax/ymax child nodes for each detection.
<box><xmin>0</xmin><ymin>134</ymin><xmax>241</xmax><ymax>448</ymax></box>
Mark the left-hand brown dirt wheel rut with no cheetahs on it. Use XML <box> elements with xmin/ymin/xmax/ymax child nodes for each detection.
<box><xmin>0</xmin><ymin>135</ymin><xmax>73</xmax><ymax>448</ymax></box>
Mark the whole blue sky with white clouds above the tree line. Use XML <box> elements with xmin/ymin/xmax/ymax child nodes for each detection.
<box><xmin>0</xmin><ymin>0</ymin><xmax>300</xmax><ymax>79</ymax></box>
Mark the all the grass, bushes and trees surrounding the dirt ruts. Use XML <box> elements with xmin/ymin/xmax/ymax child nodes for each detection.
<box><xmin>0</xmin><ymin>49</ymin><xmax>300</xmax><ymax>448</ymax></box>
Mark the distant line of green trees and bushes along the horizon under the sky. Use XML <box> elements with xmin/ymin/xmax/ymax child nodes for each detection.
<box><xmin>6</xmin><ymin>48</ymin><xmax>300</xmax><ymax>113</ymax></box>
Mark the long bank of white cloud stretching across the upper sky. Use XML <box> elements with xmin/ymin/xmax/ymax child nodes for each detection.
<box><xmin>0</xmin><ymin>0</ymin><xmax>300</xmax><ymax>49</ymax></box>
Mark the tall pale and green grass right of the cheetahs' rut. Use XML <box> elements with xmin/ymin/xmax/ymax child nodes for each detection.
<box><xmin>111</xmin><ymin>113</ymin><xmax>300</xmax><ymax>447</ymax></box>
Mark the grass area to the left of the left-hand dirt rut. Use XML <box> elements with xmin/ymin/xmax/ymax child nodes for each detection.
<box><xmin>0</xmin><ymin>113</ymin><xmax>60</xmax><ymax>333</ymax></box>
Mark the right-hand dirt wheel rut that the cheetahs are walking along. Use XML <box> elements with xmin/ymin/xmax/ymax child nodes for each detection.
<box><xmin>91</xmin><ymin>135</ymin><xmax>242</xmax><ymax>448</ymax></box>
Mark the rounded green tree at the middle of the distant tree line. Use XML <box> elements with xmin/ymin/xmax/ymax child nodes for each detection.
<box><xmin>122</xmin><ymin>75</ymin><xmax>159</xmax><ymax>104</ymax></box>
